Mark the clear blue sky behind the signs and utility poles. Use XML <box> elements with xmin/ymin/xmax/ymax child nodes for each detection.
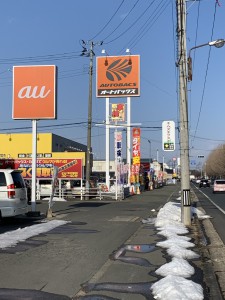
<box><xmin>0</xmin><ymin>0</ymin><xmax>225</xmax><ymax>169</ymax></box>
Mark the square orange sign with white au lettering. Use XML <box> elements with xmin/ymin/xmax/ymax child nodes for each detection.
<box><xmin>12</xmin><ymin>66</ymin><xmax>56</xmax><ymax>120</ymax></box>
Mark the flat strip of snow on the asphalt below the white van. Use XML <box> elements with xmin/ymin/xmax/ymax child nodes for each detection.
<box><xmin>0</xmin><ymin>220</ymin><xmax>68</xmax><ymax>249</ymax></box>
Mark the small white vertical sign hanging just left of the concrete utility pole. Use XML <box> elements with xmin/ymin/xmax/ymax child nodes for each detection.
<box><xmin>162</xmin><ymin>121</ymin><xmax>175</xmax><ymax>151</ymax></box>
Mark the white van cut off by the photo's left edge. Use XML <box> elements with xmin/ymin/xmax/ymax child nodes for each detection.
<box><xmin>0</xmin><ymin>169</ymin><xmax>28</xmax><ymax>218</ymax></box>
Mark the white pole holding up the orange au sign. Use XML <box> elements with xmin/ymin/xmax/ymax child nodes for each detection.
<box><xmin>31</xmin><ymin>120</ymin><xmax>37</xmax><ymax>212</ymax></box>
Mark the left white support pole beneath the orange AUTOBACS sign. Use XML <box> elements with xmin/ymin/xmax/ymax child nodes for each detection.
<box><xmin>105</xmin><ymin>98</ymin><xmax>110</xmax><ymax>191</ymax></box>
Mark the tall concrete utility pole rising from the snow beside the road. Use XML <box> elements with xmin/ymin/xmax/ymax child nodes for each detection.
<box><xmin>176</xmin><ymin>0</ymin><xmax>191</xmax><ymax>226</ymax></box>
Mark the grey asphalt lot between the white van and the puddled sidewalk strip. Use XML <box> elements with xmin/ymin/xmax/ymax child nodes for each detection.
<box><xmin>0</xmin><ymin>186</ymin><xmax>179</xmax><ymax>300</ymax></box>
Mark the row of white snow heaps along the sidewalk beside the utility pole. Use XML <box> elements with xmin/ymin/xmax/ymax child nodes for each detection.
<box><xmin>142</xmin><ymin>202</ymin><xmax>204</xmax><ymax>300</ymax></box>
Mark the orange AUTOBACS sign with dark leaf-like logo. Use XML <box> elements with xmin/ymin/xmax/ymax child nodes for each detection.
<box><xmin>96</xmin><ymin>55</ymin><xmax>140</xmax><ymax>98</ymax></box>
